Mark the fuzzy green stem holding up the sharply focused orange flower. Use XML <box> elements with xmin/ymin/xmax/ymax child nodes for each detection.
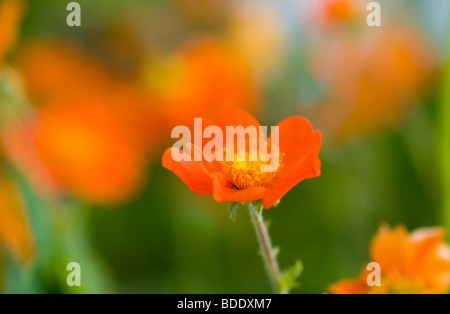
<box><xmin>248</xmin><ymin>202</ymin><xmax>285</xmax><ymax>293</ymax></box>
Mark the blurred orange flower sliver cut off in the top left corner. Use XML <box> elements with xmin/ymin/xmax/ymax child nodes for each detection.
<box><xmin>0</xmin><ymin>0</ymin><xmax>25</xmax><ymax>65</ymax></box>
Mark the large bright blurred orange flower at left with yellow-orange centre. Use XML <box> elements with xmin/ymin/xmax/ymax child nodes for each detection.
<box><xmin>3</xmin><ymin>93</ymin><xmax>146</xmax><ymax>205</ymax></box>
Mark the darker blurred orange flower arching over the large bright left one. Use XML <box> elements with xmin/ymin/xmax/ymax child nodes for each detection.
<box><xmin>17</xmin><ymin>41</ymin><xmax>160</xmax><ymax>150</ymax></box>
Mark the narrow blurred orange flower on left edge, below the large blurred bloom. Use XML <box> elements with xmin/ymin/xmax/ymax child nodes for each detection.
<box><xmin>0</xmin><ymin>170</ymin><xmax>33</xmax><ymax>262</ymax></box>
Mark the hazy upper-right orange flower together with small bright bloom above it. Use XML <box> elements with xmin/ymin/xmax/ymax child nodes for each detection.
<box><xmin>307</xmin><ymin>0</ymin><xmax>438</xmax><ymax>138</ymax></box>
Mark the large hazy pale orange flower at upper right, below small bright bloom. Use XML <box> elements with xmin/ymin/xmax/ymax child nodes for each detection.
<box><xmin>310</xmin><ymin>25</ymin><xmax>436</xmax><ymax>136</ymax></box>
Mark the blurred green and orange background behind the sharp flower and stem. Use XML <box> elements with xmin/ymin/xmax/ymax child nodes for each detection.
<box><xmin>0</xmin><ymin>0</ymin><xmax>450</xmax><ymax>293</ymax></box>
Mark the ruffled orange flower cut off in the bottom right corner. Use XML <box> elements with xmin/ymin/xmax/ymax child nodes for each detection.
<box><xmin>329</xmin><ymin>225</ymin><xmax>450</xmax><ymax>294</ymax></box>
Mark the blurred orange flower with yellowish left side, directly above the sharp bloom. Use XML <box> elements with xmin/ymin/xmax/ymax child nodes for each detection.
<box><xmin>143</xmin><ymin>39</ymin><xmax>256</xmax><ymax>130</ymax></box>
